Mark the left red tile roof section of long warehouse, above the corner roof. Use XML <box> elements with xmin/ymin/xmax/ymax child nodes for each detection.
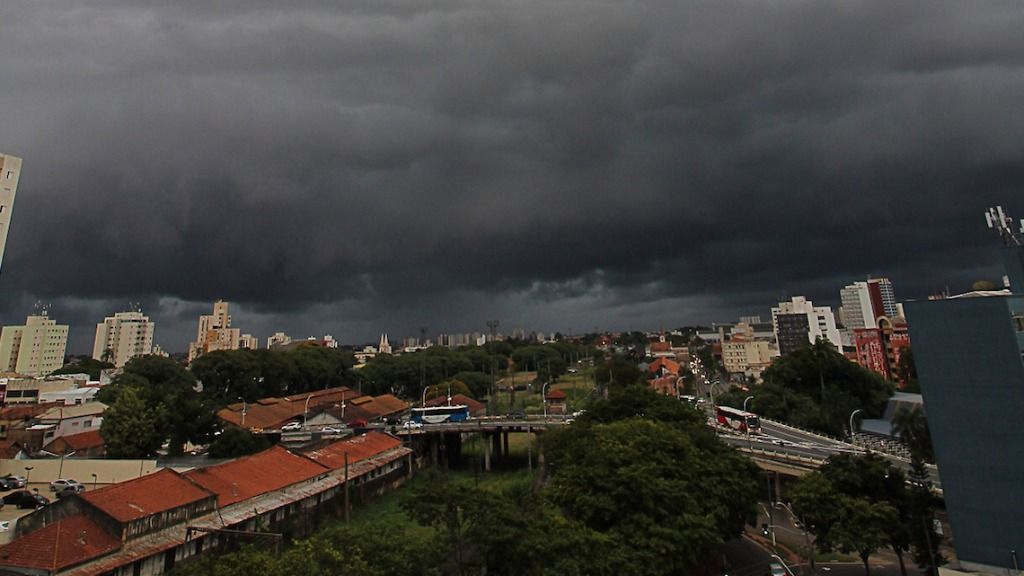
<box><xmin>80</xmin><ymin>468</ymin><xmax>211</xmax><ymax>522</ymax></box>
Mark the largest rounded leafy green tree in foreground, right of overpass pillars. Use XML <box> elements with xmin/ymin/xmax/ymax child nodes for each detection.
<box><xmin>545</xmin><ymin>417</ymin><xmax>757</xmax><ymax>574</ymax></box>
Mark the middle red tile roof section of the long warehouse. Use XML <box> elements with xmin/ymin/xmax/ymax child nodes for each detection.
<box><xmin>185</xmin><ymin>446</ymin><xmax>328</xmax><ymax>506</ymax></box>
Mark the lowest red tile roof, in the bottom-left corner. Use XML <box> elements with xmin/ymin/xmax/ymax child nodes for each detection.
<box><xmin>0</xmin><ymin>515</ymin><xmax>121</xmax><ymax>571</ymax></box>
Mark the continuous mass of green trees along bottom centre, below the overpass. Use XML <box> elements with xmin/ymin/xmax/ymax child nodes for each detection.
<box><xmin>169</xmin><ymin>384</ymin><xmax>758</xmax><ymax>576</ymax></box>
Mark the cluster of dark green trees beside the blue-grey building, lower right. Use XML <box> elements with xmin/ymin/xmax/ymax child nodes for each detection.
<box><xmin>791</xmin><ymin>454</ymin><xmax>944</xmax><ymax>576</ymax></box>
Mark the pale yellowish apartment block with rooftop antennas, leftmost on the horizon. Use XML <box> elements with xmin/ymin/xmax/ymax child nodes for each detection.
<box><xmin>0</xmin><ymin>308</ymin><xmax>68</xmax><ymax>376</ymax></box>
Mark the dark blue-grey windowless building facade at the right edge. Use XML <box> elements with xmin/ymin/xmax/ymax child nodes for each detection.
<box><xmin>906</xmin><ymin>291</ymin><xmax>1024</xmax><ymax>574</ymax></box>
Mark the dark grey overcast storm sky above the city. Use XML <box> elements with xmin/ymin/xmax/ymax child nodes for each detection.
<box><xmin>0</xmin><ymin>0</ymin><xmax>1024</xmax><ymax>352</ymax></box>
